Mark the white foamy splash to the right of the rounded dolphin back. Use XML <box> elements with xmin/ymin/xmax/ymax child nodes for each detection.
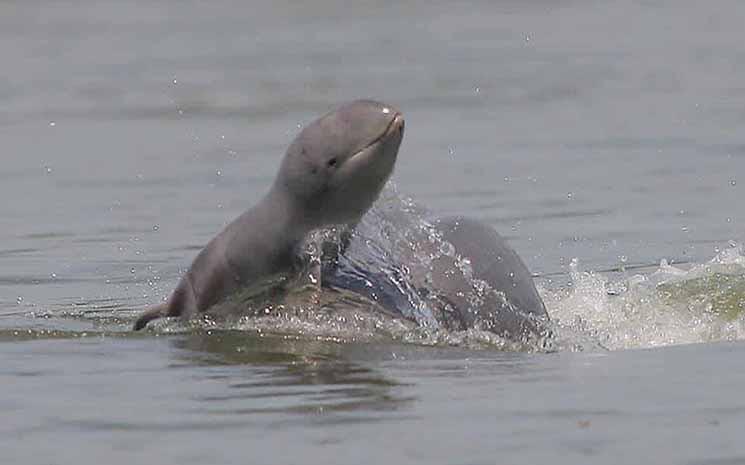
<box><xmin>541</xmin><ymin>244</ymin><xmax>745</xmax><ymax>349</ymax></box>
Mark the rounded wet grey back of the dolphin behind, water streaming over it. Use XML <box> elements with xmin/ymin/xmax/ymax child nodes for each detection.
<box><xmin>323</xmin><ymin>213</ymin><xmax>551</xmax><ymax>341</ymax></box>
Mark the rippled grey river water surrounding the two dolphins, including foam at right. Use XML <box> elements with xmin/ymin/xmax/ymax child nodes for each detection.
<box><xmin>0</xmin><ymin>0</ymin><xmax>745</xmax><ymax>464</ymax></box>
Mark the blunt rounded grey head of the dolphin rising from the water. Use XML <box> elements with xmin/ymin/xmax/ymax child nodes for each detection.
<box><xmin>274</xmin><ymin>100</ymin><xmax>404</xmax><ymax>226</ymax></box>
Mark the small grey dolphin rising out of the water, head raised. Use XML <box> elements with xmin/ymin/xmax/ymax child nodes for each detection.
<box><xmin>134</xmin><ymin>100</ymin><xmax>404</xmax><ymax>330</ymax></box>
